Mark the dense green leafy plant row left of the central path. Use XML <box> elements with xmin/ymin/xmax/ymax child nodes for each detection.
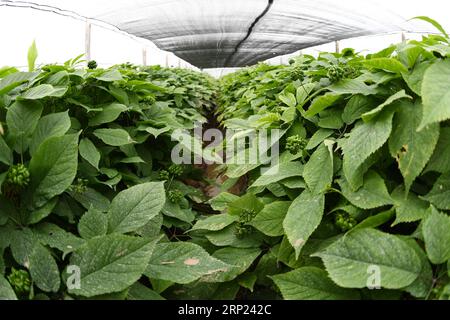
<box><xmin>0</xmin><ymin>53</ymin><xmax>220</xmax><ymax>299</ymax></box>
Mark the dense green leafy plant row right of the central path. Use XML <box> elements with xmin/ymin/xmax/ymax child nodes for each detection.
<box><xmin>209</xmin><ymin>19</ymin><xmax>450</xmax><ymax>299</ymax></box>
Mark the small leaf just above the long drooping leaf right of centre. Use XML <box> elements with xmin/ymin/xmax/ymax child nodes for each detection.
<box><xmin>303</xmin><ymin>140</ymin><xmax>333</xmax><ymax>194</ymax></box>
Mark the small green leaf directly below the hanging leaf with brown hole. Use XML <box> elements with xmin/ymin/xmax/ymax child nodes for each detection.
<box><xmin>391</xmin><ymin>186</ymin><xmax>429</xmax><ymax>226</ymax></box>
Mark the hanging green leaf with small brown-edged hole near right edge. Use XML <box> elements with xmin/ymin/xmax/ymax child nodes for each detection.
<box><xmin>389</xmin><ymin>102</ymin><xmax>439</xmax><ymax>191</ymax></box>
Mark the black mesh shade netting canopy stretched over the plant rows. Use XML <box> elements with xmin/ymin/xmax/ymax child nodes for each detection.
<box><xmin>0</xmin><ymin>0</ymin><xmax>436</xmax><ymax>68</ymax></box>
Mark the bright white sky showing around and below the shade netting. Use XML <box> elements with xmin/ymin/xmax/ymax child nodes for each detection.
<box><xmin>0</xmin><ymin>0</ymin><xmax>450</xmax><ymax>70</ymax></box>
